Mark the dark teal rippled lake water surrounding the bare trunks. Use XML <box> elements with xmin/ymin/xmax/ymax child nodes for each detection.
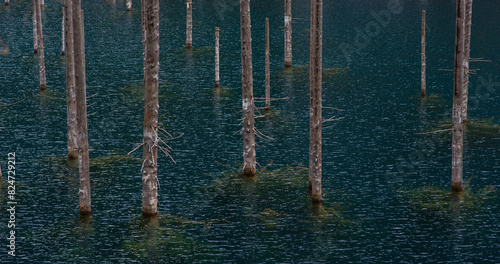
<box><xmin>0</xmin><ymin>0</ymin><xmax>500</xmax><ymax>263</ymax></box>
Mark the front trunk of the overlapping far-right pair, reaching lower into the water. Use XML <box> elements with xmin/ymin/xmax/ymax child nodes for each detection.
<box><xmin>451</xmin><ymin>0</ymin><xmax>467</xmax><ymax>192</ymax></box>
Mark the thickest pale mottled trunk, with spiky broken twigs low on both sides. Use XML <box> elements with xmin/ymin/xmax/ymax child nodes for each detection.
<box><xmin>142</xmin><ymin>0</ymin><xmax>160</xmax><ymax>216</ymax></box>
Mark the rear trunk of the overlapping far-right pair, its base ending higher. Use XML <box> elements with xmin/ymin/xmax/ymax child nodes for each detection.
<box><xmin>462</xmin><ymin>0</ymin><xmax>472</xmax><ymax>124</ymax></box>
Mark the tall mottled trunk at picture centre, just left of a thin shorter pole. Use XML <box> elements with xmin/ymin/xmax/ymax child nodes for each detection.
<box><xmin>240</xmin><ymin>0</ymin><xmax>257</xmax><ymax>177</ymax></box>
